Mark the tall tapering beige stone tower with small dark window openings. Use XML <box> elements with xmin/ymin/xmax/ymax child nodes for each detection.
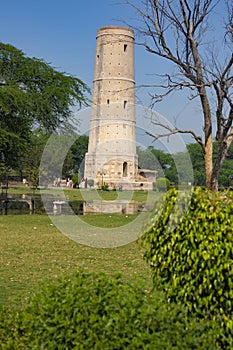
<box><xmin>84</xmin><ymin>26</ymin><xmax>138</xmax><ymax>187</ymax></box>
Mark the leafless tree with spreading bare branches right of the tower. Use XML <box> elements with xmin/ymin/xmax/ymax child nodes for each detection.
<box><xmin>126</xmin><ymin>0</ymin><xmax>233</xmax><ymax>191</ymax></box>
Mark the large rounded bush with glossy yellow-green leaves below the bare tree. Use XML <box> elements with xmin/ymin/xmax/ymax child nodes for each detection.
<box><xmin>142</xmin><ymin>188</ymin><xmax>233</xmax><ymax>341</ymax></box>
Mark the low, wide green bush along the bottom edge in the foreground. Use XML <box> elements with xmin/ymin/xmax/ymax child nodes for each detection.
<box><xmin>0</xmin><ymin>273</ymin><xmax>217</xmax><ymax>350</ymax></box>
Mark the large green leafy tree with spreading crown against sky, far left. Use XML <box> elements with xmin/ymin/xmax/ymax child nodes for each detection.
<box><xmin>0</xmin><ymin>43</ymin><xmax>88</xmax><ymax>176</ymax></box>
